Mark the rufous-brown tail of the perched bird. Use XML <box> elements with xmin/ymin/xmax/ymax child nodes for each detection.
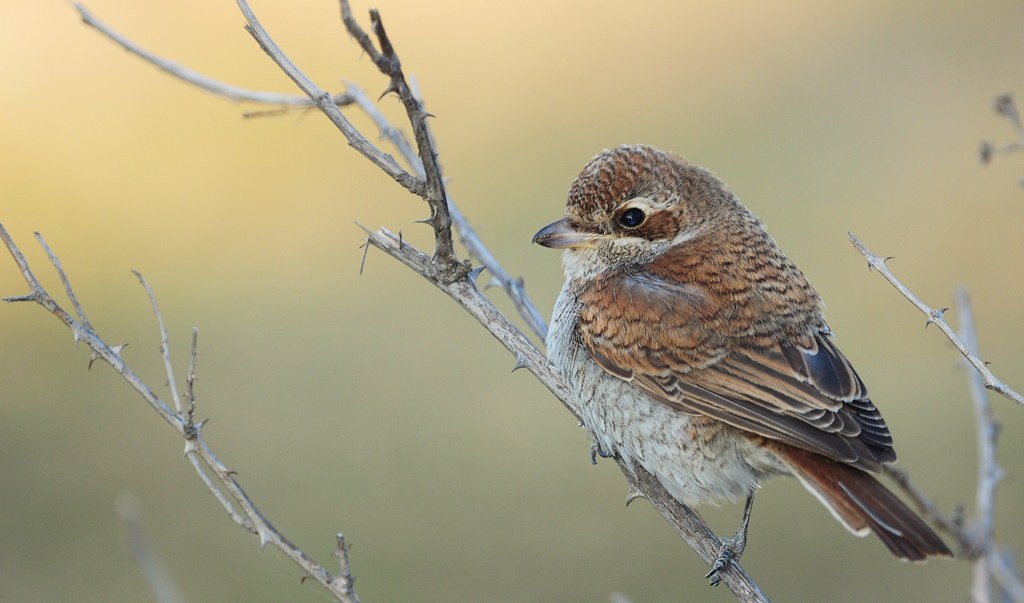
<box><xmin>777</xmin><ymin>444</ymin><xmax>953</xmax><ymax>561</ymax></box>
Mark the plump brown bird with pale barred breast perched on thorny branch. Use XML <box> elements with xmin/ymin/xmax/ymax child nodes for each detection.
<box><xmin>534</xmin><ymin>144</ymin><xmax>952</xmax><ymax>585</ymax></box>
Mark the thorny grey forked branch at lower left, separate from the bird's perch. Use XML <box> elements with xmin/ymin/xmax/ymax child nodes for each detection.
<box><xmin>0</xmin><ymin>224</ymin><xmax>358</xmax><ymax>603</ymax></box>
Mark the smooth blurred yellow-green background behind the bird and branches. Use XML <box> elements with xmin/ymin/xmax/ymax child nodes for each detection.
<box><xmin>0</xmin><ymin>0</ymin><xmax>1024</xmax><ymax>603</ymax></box>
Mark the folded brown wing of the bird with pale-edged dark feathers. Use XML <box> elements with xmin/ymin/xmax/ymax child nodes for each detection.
<box><xmin>579</xmin><ymin>271</ymin><xmax>896</xmax><ymax>470</ymax></box>
